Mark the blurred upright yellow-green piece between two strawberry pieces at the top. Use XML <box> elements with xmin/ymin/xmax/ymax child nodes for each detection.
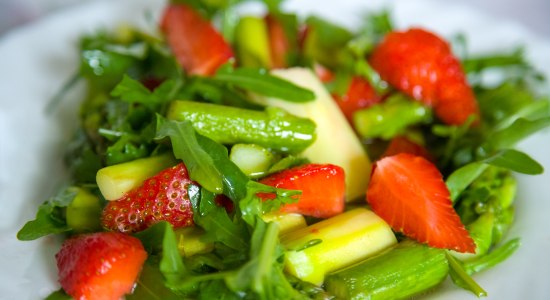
<box><xmin>235</xmin><ymin>16</ymin><xmax>271</xmax><ymax>68</ymax></box>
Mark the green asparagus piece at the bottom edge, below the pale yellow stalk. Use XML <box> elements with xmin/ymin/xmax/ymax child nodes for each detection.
<box><xmin>325</xmin><ymin>240</ymin><xmax>449</xmax><ymax>300</ymax></box>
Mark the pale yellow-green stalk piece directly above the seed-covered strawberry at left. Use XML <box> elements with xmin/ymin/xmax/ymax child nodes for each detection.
<box><xmin>96</xmin><ymin>154</ymin><xmax>177</xmax><ymax>200</ymax></box>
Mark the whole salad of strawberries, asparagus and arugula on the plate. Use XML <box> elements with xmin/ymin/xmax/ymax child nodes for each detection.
<box><xmin>18</xmin><ymin>1</ymin><xmax>549</xmax><ymax>299</ymax></box>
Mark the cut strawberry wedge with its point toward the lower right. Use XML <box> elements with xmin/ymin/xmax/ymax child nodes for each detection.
<box><xmin>367</xmin><ymin>153</ymin><xmax>476</xmax><ymax>253</ymax></box>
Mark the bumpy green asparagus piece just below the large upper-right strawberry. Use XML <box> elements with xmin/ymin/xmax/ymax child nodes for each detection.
<box><xmin>353</xmin><ymin>95</ymin><xmax>432</xmax><ymax>140</ymax></box>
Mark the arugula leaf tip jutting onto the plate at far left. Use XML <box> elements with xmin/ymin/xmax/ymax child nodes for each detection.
<box><xmin>17</xmin><ymin>188</ymin><xmax>77</xmax><ymax>241</ymax></box>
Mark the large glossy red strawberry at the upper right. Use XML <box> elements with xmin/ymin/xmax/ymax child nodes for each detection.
<box><xmin>370</xmin><ymin>28</ymin><xmax>480</xmax><ymax>125</ymax></box>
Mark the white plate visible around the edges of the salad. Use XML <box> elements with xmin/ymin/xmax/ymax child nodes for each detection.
<box><xmin>0</xmin><ymin>0</ymin><xmax>550</xmax><ymax>299</ymax></box>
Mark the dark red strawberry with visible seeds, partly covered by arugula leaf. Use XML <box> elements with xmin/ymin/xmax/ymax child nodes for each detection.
<box><xmin>101</xmin><ymin>163</ymin><xmax>193</xmax><ymax>232</ymax></box>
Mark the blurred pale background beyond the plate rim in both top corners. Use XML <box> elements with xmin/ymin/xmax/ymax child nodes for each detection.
<box><xmin>0</xmin><ymin>0</ymin><xmax>550</xmax><ymax>39</ymax></box>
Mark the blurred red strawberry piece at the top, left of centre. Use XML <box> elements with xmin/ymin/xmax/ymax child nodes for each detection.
<box><xmin>160</xmin><ymin>4</ymin><xmax>233</xmax><ymax>76</ymax></box>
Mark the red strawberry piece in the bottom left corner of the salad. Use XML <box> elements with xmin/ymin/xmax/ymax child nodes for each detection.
<box><xmin>55</xmin><ymin>232</ymin><xmax>147</xmax><ymax>300</ymax></box>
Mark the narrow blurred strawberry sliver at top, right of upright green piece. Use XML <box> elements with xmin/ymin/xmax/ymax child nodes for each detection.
<box><xmin>265</xmin><ymin>14</ymin><xmax>290</xmax><ymax>68</ymax></box>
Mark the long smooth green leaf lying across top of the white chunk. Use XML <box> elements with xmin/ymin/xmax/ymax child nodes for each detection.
<box><xmin>214</xmin><ymin>67</ymin><xmax>315</xmax><ymax>103</ymax></box>
